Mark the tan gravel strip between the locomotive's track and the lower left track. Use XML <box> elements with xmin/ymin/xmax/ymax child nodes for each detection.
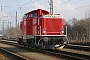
<box><xmin>0</xmin><ymin>43</ymin><xmax>62</xmax><ymax>60</ymax></box>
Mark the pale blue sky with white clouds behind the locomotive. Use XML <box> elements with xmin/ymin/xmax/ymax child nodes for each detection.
<box><xmin>0</xmin><ymin>0</ymin><xmax>90</xmax><ymax>26</ymax></box>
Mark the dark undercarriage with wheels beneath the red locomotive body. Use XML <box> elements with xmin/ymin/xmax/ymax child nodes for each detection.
<box><xmin>19</xmin><ymin>36</ymin><xmax>68</xmax><ymax>49</ymax></box>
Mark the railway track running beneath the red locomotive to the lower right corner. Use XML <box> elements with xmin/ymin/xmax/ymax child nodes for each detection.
<box><xmin>0</xmin><ymin>41</ymin><xmax>90</xmax><ymax>60</ymax></box>
